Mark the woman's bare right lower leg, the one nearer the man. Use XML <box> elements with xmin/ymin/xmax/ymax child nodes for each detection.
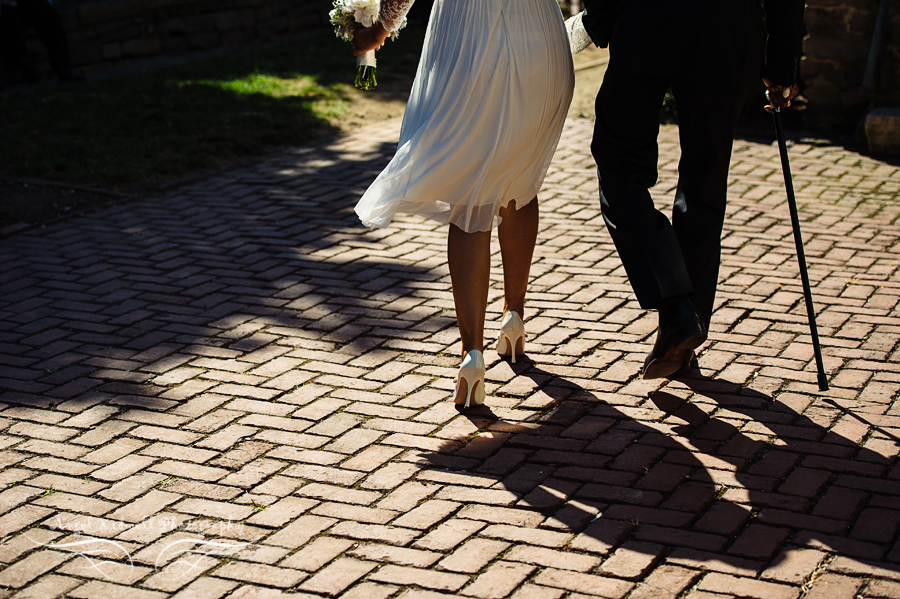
<box><xmin>499</xmin><ymin>198</ymin><xmax>538</xmax><ymax>318</ymax></box>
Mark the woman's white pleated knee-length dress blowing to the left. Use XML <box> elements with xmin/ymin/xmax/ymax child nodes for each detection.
<box><xmin>356</xmin><ymin>0</ymin><xmax>575</xmax><ymax>233</ymax></box>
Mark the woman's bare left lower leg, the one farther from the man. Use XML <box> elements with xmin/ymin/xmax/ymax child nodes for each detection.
<box><xmin>447</xmin><ymin>225</ymin><xmax>491</xmax><ymax>356</ymax></box>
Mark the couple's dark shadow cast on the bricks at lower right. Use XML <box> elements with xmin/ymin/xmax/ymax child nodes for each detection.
<box><xmin>428</xmin><ymin>361</ymin><xmax>900</xmax><ymax>596</ymax></box>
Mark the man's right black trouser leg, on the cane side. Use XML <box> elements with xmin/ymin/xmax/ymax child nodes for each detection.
<box><xmin>672</xmin><ymin>80</ymin><xmax>746</xmax><ymax>330</ymax></box>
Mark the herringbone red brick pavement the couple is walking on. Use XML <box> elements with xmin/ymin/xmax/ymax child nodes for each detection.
<box><xmin>0</xmin><ymin>121</ymin><xmax>900</xmax><ymax>599</ymax></box>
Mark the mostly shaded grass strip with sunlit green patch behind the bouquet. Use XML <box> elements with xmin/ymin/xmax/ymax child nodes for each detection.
<box><xmin>0</xmin><ymin>27</ymin><xmax>424</xmax><ymax>189</ymax></box>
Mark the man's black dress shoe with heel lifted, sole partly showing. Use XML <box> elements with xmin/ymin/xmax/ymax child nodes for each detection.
<box><xmin>644</xmin><ymin>298</ymin><xmax>706</xmax><ymax>379</ymax></box>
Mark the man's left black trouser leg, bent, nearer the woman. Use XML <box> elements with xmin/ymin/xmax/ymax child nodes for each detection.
<box><xmin>591</xmin><ymin>69</ymin><xmax>692</xmax><ymax>308</ymax></box>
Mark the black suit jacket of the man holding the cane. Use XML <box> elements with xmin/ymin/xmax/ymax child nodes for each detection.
<box><xmin>583</xmin><ymin>0</ymin><xmax>804</xmax><ymax>86</ymax></box>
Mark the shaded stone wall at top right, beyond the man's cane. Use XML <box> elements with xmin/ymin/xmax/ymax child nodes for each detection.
<box><xmin>800</xmin><ymin>0</ymin><xmax>900</xmax><ymax>132</ymax></box>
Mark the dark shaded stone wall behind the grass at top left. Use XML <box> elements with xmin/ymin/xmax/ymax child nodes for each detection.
<box><xmin>18</xmin><ymin>0</ymin><xmax>330</xmax><ymax>78</ymax></box>
